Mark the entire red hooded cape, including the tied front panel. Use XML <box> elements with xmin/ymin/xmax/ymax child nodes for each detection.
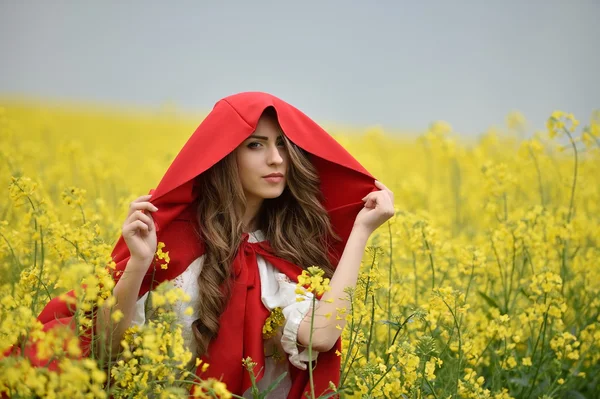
<box><xmin>9</xmin><ymin>92</ymin><xmax>377</xmax><ymax>399</ymax></box>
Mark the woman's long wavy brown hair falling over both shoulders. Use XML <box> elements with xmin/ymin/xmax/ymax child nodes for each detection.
<box><xmin>192</xmin><ymin>108</ymin><xmax>339</xmax><ymax>356</ymax></box>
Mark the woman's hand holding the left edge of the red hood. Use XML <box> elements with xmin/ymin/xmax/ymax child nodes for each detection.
<box><xmin>121</xmin><ymin>195</ymin><xmax>158</xmax><ymax>273</ymax></box>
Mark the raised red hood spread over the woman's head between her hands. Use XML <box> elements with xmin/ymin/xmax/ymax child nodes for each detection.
<box><xmin>108</xmin><ymin>92</ymin><xmax>377</xmax><ymax>296</ymax></box>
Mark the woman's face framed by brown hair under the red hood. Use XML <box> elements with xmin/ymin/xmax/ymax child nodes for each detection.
<box><xmin>235</xmin><ymin>115</ymin><xmax>288</xmax><ymax>202</ymax></box>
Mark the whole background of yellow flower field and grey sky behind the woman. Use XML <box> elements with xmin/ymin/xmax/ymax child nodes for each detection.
<box><xmin>0</xmin><ymin>0</ymin><xmax>600</xmax><ymax>399</ymax></box>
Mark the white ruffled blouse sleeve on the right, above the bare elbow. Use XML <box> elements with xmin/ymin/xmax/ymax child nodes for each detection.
<box><xmin>257</xmin><ymin>256</ymin><xmax>319</xmax><ymax>370</ymax></box>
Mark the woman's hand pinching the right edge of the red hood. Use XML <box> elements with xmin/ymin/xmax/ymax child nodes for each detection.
<box><xmin>354</xmin><ymin>180</ymin><xmax>396</xmax><ymax>234</ymax></box>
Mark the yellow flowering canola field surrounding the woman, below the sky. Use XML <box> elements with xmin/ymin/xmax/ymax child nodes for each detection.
<box><xmin>0</xmin><ymin>102</ymin><xmax>600</xmax><ymax>399</ymax></box>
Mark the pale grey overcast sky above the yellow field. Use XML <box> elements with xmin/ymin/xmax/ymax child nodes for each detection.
<box><xmin>0</xmin><ymin>0</ymin><xmax>600</xmax><ymax>135</ymax></box>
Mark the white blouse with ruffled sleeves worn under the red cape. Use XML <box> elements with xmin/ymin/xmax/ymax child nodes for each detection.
<box><xmin>131</xmin><ymin>230</ymin><xmax>319</xmax><ymax>398</ymax></box>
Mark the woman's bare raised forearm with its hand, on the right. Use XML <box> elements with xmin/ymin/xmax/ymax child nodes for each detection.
<box><xmin>298</xmin><ymin>180</ymin><xmax>395</xmax><ymax>352</ymax></box>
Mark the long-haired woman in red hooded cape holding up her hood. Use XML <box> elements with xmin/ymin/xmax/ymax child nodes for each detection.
<box><xmin>40</xmin><ymin>92</ymin><xmax>394</xmax><ymax>398</ymax></box>
